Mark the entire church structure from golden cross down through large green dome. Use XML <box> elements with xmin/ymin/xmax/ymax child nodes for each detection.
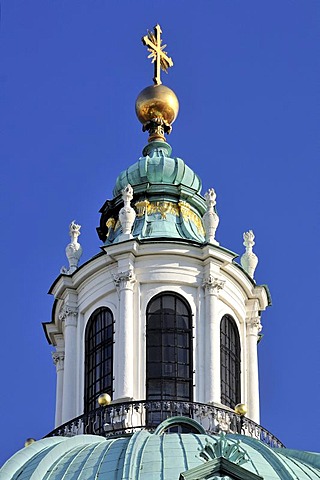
<box><xmin>0</xmin><ymin>25</ymin><xmax>320</xmax><ymax>480</ymax></box>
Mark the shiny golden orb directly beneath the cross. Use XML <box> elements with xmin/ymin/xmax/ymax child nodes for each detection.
<box><xmin>136</xmin><ymin>84</ymin><xmax>179</xmax><ymax>125</ymax></box>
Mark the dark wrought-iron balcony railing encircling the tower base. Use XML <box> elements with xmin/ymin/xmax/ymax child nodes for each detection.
<box><xmin>46</xmin><ymin>400</ymin><xmax>284</xmax><ymax>447</ymax></box>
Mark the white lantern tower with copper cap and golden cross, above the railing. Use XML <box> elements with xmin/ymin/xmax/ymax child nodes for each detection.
<box><xmin>44</xmin><ymin>25</ymin><xmax>270</xmax><ymax>427</ymax></box>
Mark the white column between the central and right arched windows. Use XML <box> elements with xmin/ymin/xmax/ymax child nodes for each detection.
<box><xmin>203</xmin><ymin>275</ymin><xmax>225</xmax><ymax>403</ymax></box>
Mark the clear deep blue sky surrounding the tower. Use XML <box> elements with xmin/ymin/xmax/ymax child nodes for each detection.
<box><xmin>0</xmin><ymin>0</ymin><xmax>320</xmax><ymax>464</ymax></box>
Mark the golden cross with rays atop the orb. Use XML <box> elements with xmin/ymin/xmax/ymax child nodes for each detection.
<box><xmin>142</xmin><ymin>24</ymin><xmax>173</xmax><ymax>85</ymax></box>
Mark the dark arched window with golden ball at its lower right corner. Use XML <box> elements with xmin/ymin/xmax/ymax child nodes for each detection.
<box><xmin>84</xmin><ymin>307</ymin><xmax>114</xmax><ymax>413</ymax></box>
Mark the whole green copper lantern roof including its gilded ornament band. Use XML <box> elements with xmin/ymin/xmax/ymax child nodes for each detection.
<box><xmin>97</xmin><ymin>141</ymin><xmax>206</xmax><ymax>245</ymax></box>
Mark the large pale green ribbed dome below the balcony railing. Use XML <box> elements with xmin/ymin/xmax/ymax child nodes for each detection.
<box><xmin>0</xmin><ymin>430</ymin><xmax>320</xmax><ymax>480</ymax></box>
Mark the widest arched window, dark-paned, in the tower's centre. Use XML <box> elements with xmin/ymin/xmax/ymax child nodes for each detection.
<box><xmin>146</xmin><ymin>292</ymin><xmax>193</xmax><ymax>401</ymax></box>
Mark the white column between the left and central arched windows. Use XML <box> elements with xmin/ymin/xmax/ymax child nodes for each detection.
<box><xmin>113</xmin><ymin>270</ymin><xmax>136</xmax><ymax>400</ymax></box>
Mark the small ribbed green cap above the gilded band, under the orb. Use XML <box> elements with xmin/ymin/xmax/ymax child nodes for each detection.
<box><xmin>113</xmin><ymin>142</ymin><xmax>201</xmax><ymax>197</ymax></box>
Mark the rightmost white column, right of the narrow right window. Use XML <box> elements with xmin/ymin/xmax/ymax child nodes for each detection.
<box><xmin>246</xmin><ymin>317</ymin><xmax>262</xmax><ymax>423</ymax></box>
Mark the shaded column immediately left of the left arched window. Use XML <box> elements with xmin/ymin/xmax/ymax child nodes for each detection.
<box><xmin>59</xmin><ymin>304</ymin><xmax>79</xmax><ymax>423</ymax></box>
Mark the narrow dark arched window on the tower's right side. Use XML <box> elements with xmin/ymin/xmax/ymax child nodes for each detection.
<box><xmin>220</xmin><ymin>315</ymin><xmax>241</xmax><ymax>408</ymax></box>
